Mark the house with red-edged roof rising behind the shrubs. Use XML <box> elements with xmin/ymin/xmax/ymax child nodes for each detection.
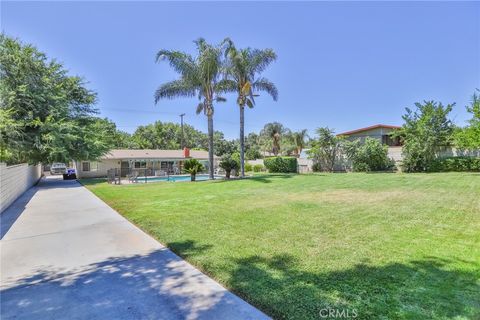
<box><xmin>337</xmin><ymin>124</ymin><xmax>401</xmax><ymax>147</ymax></box>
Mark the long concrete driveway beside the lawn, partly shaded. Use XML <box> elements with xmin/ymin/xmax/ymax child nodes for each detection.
<box><xmin>0</xmin><ymin>177</ymin><xmax>268</xmax><ymax>320</ymax></box>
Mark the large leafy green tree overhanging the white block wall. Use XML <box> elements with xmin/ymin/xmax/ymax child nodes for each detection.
<box><xmin>0</xmin><ymin>34</ymin><xmax>109</xmax><ymax>163</ymax></box>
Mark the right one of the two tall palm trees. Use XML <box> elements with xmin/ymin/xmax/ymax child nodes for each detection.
<box><xmin>226</xmin><ymin>40</ymin><xmax>278</xmax><ymax>177</ymax></box>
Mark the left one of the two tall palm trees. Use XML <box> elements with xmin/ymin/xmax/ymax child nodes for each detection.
<box><xmin>155</xmin><ymin>38</ymin><xmax>228</xmax><ymax>179</ymax></box>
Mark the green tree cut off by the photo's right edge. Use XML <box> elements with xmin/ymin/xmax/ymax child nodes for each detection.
<box><xmin>455</xmin><ymin>89</ymin><xmax>480</xmax><ymax>150</ymax></box>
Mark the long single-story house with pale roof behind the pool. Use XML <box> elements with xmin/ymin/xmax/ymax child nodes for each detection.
<box><xmin>75</xmin><ymin>148</ymin><xmax>218</xmax><ymax>178</ymax></box>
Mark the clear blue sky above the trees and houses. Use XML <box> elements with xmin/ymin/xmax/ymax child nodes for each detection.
<box><xmin>1</xmin><ymin>1</ymin><xmax>480</xmax><ymax>138</ymax></box>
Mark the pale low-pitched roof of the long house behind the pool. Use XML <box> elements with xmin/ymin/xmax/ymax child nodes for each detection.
<box><xmin>102</xmin><ymin>149</ymin><xmax>212</xmax><ymax>160</ymax></box>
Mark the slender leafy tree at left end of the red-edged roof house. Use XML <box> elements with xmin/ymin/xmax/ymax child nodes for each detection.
<box><xmin>307</xmin><ymin>127</ymin><xmax>344</xmax><ymax>172</ymax></box>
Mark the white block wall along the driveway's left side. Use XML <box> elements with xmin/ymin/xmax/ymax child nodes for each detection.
<box><xmin>0</xmin><ymin>163</ymin><xmax>42</xmax><ymax>213</ymax></box>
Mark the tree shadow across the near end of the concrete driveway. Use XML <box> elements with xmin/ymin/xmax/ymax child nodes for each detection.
<box><xmin>1</xmin><ymin>249</ymin><xmax>265</xmax><ymax>320</ymax></box>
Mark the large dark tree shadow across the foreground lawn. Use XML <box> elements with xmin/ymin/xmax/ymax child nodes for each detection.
<box><xmin>228</xmin><ymin>255</ymin><xmax>480</xmax><ymax>319</ymax></box>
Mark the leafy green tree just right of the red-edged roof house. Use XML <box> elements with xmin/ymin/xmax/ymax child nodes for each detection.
<box><xmin>393</xmin><ymin>101</ymin><xmax>454</xmax><ymax>172</ymax></box>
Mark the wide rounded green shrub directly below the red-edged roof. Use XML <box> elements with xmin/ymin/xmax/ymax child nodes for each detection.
<box><xmin>345</xmin><ymin>138</ymin><xmax>395</xmax><ymax>172</ymax></box>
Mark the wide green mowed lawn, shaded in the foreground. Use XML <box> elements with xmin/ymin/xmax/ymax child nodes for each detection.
<box><xmin>82</xmin><ymin>173</ymin><xmax>480</xmax><ymax>319</ymax></box>
